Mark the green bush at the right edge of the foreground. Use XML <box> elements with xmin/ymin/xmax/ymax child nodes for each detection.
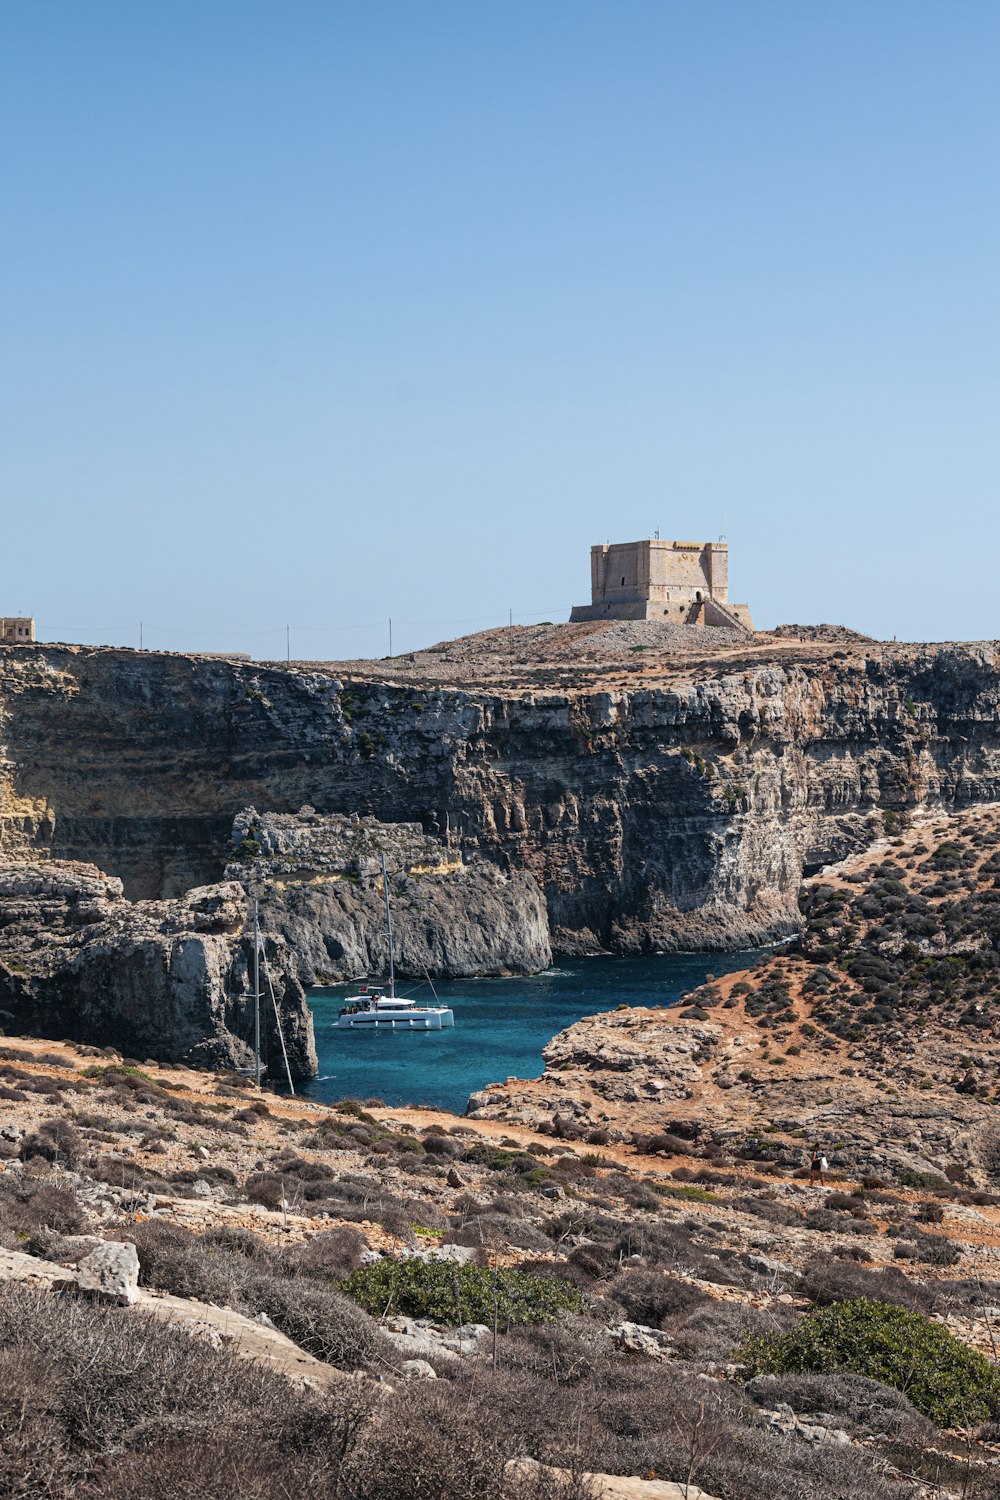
<box><xmin>739</xmin><ymin>1298</ymin><xmax>1000</xmax><ymax>1427</ymax></box>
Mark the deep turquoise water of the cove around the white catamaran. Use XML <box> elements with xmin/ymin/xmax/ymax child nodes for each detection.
<box><xmin>306</xmin><ymin>953</ymin><xmax>757</xmax><ymax>1115</ymax></box>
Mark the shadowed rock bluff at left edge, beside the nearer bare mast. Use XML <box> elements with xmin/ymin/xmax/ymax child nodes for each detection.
<box><xmin>0</xmin><ymin>861</ymin><xmax>316</xmax><ymax>1077</ymax></box>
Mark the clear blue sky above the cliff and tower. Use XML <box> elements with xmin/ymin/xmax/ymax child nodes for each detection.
<box><xmin>0</xmin><ymin>0</ymin><xmax>1000</xmax><ymax>657</ymax></box>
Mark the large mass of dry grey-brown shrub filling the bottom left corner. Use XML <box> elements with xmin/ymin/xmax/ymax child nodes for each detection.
<box><xmin>0</xmin><ymin>1287</ymin><xmax>388</xmax><ymax>1500</ymax></box>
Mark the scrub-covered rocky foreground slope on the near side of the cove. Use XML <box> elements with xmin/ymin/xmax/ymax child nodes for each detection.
<box><xmin>0</xmin><ymin>1038</ymin><xmax>1000</xmax><ymax>1500</ymax></box>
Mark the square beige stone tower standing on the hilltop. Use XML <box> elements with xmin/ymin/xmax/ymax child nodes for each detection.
<box><xmin>570</xmin><ymin>537</ymin><xmax>754</xmax><ymax>630</ymax></box>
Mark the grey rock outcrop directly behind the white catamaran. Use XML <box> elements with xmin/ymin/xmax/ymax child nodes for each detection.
<box><xmin>226</xmin><ymin>807</ymin><xmax>552</xmax><ymax>984</ymax></box>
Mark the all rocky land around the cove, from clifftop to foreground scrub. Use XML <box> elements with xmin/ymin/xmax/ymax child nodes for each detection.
<box><xmin>9</xmin><ymin>623</ymin><xmax>1000</xmax><ymax>1500</ymax></box>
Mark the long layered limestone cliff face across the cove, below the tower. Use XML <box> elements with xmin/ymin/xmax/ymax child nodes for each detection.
<box><xmin>0</xmin><ymin>642</ymin><xmax>1000</xmax><ymax>953</ymax></box>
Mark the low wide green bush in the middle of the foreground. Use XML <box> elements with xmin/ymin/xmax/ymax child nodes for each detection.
<box><xmin>342</xmin><ymin>1256</ymin><xmax>585</xmax><ymax>1329</ymax></box>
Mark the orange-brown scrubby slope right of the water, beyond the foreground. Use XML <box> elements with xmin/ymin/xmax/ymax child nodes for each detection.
<box><xmin>471</xmin><ymin>807</ymin><xmax>1000</xmax><ymax>1200</ymax></box>
